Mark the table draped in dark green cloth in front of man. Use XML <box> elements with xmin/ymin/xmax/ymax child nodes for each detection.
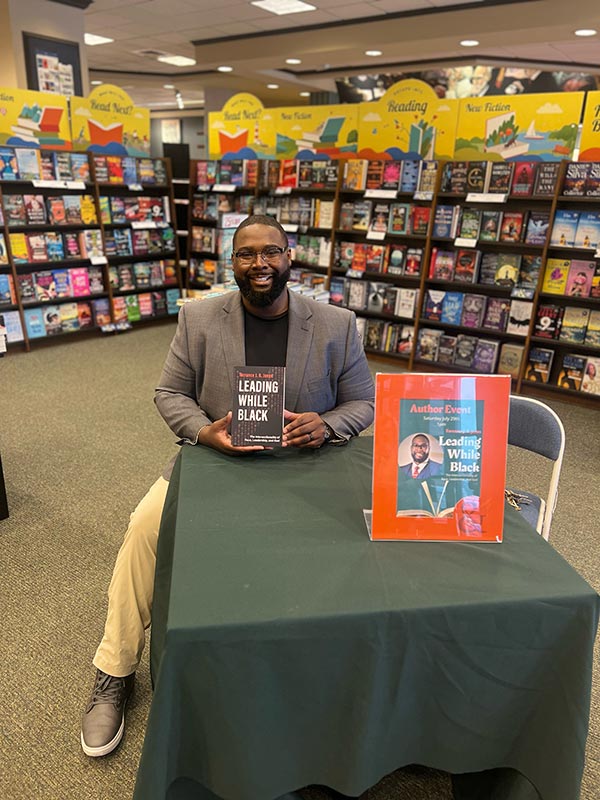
<box><xmin>134</xmin><ymin>437</ymin><xmax>599</xmax><ymax>800</ymax></box>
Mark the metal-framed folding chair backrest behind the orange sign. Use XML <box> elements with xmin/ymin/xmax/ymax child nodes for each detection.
<box><xmin>508</xmin><ymin>395</ymin><xmax>565</xmax><ymax>539</ymax></box>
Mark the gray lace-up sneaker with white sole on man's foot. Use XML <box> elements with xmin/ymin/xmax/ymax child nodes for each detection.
<box><xmin>81</xmin><ymin>669</ymin><xmax>135</xmax><ymax>757</ymax></box>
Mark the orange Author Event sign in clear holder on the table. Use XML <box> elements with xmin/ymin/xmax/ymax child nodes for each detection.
<box><xmin>370</xmin><ymin>374</ymin><xmax>510</xmax><ymax>542</ymax></box>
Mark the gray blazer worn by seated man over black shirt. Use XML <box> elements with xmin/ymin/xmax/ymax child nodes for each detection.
<box><xmin>154</xmin><ymin>292</ymin><xmax>375</xmax><ymax>478</ymax></box>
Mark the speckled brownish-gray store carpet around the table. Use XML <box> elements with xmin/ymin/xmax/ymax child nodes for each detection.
<box><xmin>0</xmin><ymin>321</ymin><xmax>600</xmax><ymax>800</ymax></box>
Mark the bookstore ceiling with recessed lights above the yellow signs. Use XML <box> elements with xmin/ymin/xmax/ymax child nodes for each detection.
<box><xmin>85</xmin><ymin>0</ymin><xmax>600</xmax><ymax>111</ymax></box>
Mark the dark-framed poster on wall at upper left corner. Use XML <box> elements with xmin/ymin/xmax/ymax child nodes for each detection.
<box><xmin>23</xmin><ymin>31</ymin><xmax>83</xmax><ymax>97</ymax></box>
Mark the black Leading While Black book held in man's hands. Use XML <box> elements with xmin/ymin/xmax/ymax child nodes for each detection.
<box><xmin>231</xmin><ymin>366</ymin><xmax>285</xmax><ymax>447</ymax></box>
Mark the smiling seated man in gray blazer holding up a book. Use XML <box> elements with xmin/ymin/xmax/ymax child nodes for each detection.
<box><xmin>81</xmin><ymin>211</ymin><xmax>374</xmax><ymax>756</ymax></box>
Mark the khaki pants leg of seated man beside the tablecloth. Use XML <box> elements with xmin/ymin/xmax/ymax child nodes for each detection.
<box><xmin>94</xmin><ymin>478</ymin><xmax>169</xmax><ymax>678</ymax></box>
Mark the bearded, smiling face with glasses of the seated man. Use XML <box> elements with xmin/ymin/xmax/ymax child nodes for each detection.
<box><xmin>232</xmin><ymin>225</ymin><xmax>290</xmax><ymax>308</ymax></box>
